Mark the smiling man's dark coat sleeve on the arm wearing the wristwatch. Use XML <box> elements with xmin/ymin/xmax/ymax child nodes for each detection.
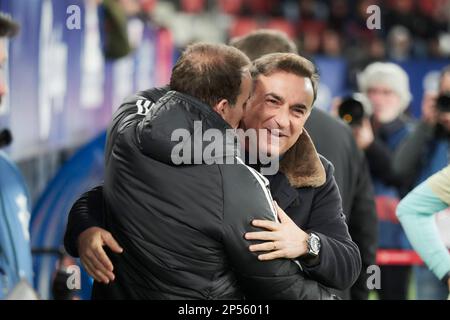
<box><xmin>303</xmin><ymin>159</ymin><xmax>361</xmax><ymax>290</ymax></box>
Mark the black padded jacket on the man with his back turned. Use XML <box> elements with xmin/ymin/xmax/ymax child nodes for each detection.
<box><xmin>65</xmin><ymin>91</ymin><xmax>336</xmax><ymax>299</ymax></box>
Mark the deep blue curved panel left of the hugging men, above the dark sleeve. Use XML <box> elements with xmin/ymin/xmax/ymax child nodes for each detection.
<box><xmin>31</xmin><ymin>133</ymin><xmax>106</xmax><ymax>299</ymax></box>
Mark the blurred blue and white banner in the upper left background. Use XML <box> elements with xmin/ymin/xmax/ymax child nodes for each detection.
<box><xmin>0</xmin><ymin>0</ymin><xmax>173</xmax><ymax>160</ymax></box>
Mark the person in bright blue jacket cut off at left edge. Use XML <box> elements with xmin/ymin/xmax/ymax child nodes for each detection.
<box><xmin>0</xmin><ymin>12</ymin><xmax>33</xmax><ymax>299</ymax></box>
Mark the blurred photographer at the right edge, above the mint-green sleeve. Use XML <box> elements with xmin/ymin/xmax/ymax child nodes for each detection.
<box><xmin>393</xmin><ymin>66</ymin><xmax>450</xmax><ymax>299</ymax></box>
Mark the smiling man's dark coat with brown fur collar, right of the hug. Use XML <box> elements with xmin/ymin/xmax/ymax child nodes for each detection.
<box><xmin>274</xmin><ymin>130</ymin><xmax>361</xmax><ymax>290</ymax></box>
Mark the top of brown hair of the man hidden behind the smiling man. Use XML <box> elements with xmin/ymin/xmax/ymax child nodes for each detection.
<box><xmin>230</xmin><ymin>29</ymin><xmax>298</xmax><ymax>61</ymax></box>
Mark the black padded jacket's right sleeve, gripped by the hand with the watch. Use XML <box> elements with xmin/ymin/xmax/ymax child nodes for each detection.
<box><xmin>222</xmin><ymin>166</ymin><xmax>334</xmax><ymax>300</ymax></box>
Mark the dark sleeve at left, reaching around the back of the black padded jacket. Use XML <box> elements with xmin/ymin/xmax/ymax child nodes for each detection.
<box><xmin>64</xmin><ymin>186</ymin><xmax>104</xmax><ymax>257</ymax></box>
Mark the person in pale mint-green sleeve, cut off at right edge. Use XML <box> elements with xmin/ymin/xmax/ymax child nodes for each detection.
<box><xmin>397</xmin><ymin>165</ymin><xmax>450</xmax><ymax>300</ymax></box>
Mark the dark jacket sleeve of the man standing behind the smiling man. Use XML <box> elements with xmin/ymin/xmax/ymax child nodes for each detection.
<box><xmin>348</xmin><ymin>156</ymin><xmax>378</xmax><ymax>300</ymax></box>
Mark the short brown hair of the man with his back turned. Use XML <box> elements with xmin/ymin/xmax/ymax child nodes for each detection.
<box><xmin>170</xmin><ymin>43</ymin><xmax>251</xmax><ymax>107</ymax></box>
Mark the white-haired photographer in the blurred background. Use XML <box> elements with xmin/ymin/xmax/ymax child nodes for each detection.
<box><xmin>353</xmin><ymin>62</ymin><xmax>412</xmax><ymax>300</ymax></box>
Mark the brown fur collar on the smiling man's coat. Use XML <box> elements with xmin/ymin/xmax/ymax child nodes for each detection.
<box><xmin>280</xmin><ymin>129</ymin><xmax>326</xmax><ymax>188</ymax></box>
